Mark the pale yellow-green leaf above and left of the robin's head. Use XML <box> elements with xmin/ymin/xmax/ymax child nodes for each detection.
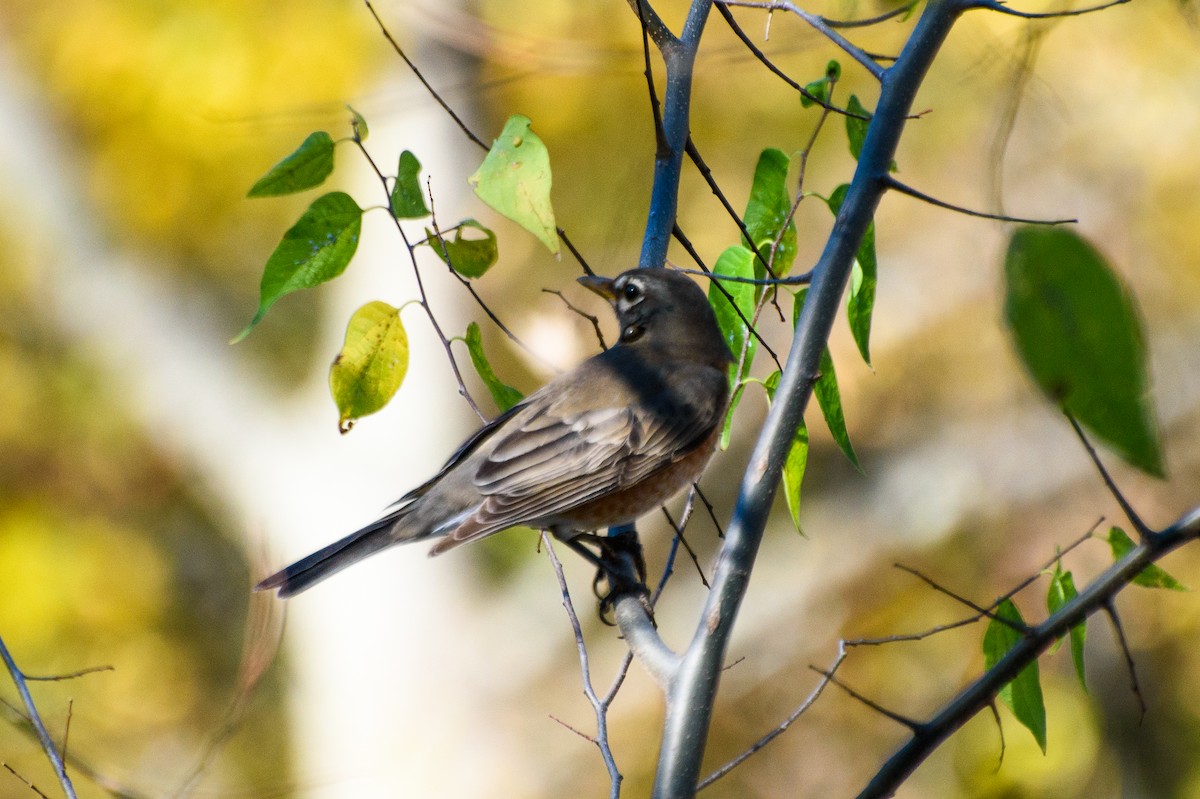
<box><xmin>467</xmin><ymin>114</ymin><xmax>558</xmax><ymax>254</ymax></box>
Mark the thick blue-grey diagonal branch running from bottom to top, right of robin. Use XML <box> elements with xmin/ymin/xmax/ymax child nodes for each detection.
<box><xmin>653</xmin><ymin>0</ymin><xmax>967</xmax><ymax>799</ymax></box>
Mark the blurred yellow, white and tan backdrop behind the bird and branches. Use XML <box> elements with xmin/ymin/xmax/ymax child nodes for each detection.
<box><xmin>0</xmin><ymin>0</ymin><xmax>1200</xmax><ymax>799</ymax></box>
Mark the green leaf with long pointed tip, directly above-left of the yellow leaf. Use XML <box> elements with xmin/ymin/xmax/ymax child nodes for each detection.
<box><xmin>234</xmin><ymin>192</ymin><xmax>362</xmax><ymax>343</ymax></box>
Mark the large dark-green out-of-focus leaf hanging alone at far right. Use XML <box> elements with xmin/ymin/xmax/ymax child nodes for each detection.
<box><xmin>1004</xmin><ymin>227</ymin><xmax>1163</xmax><ymax>476</ymax></box>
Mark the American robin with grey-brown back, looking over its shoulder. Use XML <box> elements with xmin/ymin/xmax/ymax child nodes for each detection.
<box><xmin>254</xmin><ymin>269</ymin><xmax>733</xmax><ymax>597</ymax></box>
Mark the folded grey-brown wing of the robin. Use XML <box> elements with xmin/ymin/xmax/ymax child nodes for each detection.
<box><xmin>438</xmin><ymin>366</ymin><xmax>727</xmax><ymax>551</ymax></box>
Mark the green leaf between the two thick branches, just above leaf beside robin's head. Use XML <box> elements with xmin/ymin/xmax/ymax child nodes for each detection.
<box><xmin>743</xmin><ymin>148</ymin><xmax>796</xmax><ymax>281</ymax></box>
